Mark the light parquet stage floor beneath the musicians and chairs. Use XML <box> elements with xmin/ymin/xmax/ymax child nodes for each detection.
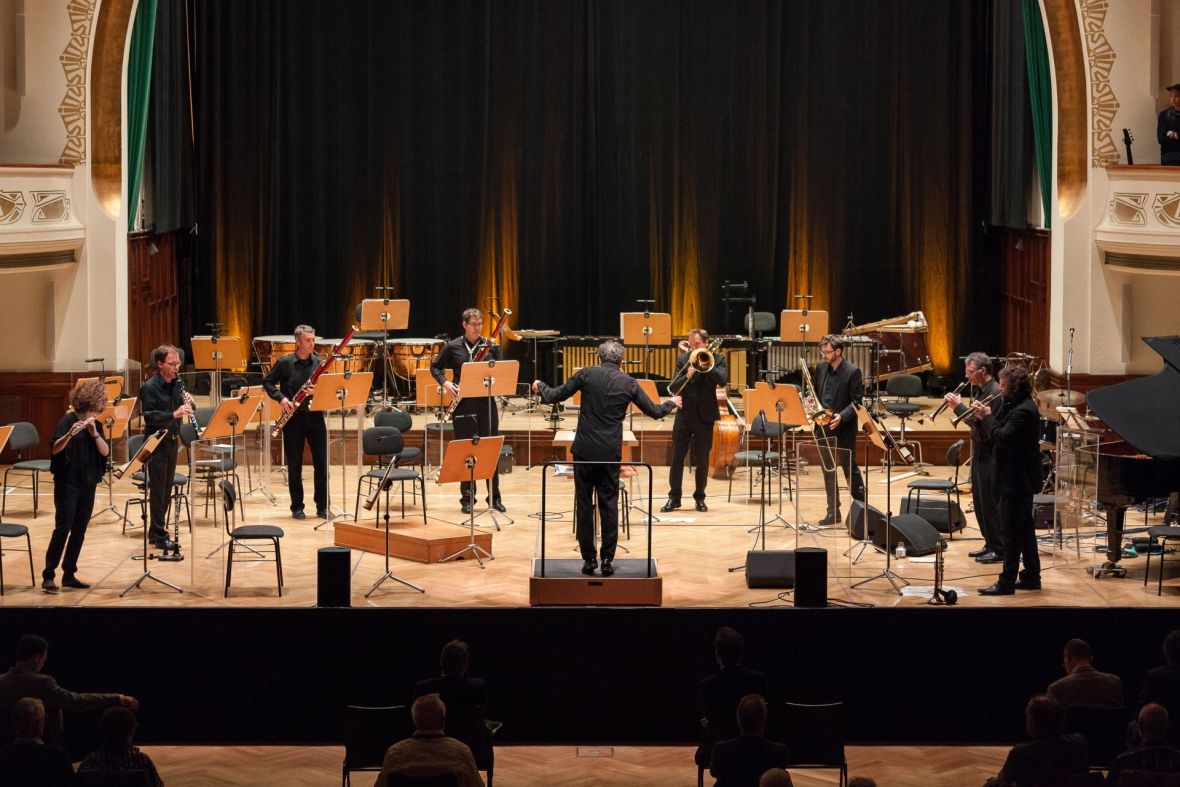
<box><xmin>0</xmin><ymin>455</ymin><xmax>1180</xmax><ymax>608</ymax></box>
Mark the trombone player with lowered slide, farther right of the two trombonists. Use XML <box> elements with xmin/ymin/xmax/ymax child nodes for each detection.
<box><xmin>815</xmin><ymin>334</ymin><xmax>865</xmax><ymax>525</ymax></box>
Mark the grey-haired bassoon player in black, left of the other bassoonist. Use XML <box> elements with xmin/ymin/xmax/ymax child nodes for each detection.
<box><xmin>262</xmin><ymin>326</ymin><xmax>328</xmax><ymax>519</ymax></box>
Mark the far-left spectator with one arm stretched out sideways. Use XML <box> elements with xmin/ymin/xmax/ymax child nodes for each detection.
<box><xmin>0</xmin><ymin>634</ymin><xmax>139</xmax><ymax>748</ymax></box>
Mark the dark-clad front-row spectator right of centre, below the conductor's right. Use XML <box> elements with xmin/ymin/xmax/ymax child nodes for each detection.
<box><xmin>694</xmin><ymin>625</ymin><xmax>769</xmax><ymax>767</ymax></box>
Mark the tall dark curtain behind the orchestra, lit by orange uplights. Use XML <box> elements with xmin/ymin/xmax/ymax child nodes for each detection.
<box><xmin>186</xmin><ymin>0</ymin><xmax>991</xmax><ymax>368</ymax></box>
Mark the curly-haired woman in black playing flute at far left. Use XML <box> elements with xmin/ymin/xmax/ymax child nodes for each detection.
<box><xmin>41</xmin><ymin>380</ymin><xmax>111</xmax><ymax>592</ymax></box>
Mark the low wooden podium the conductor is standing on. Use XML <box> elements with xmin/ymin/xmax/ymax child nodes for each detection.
<box><xmin>529</xmin><ymin>558</ymin><xmax>663</xmax><ymax>606</ymax></box>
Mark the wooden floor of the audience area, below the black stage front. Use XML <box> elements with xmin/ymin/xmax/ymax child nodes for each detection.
<box><xmin>144</xmin><ymin>746</ymin><xmax>1008</xmax><ymax>787</ymax></box>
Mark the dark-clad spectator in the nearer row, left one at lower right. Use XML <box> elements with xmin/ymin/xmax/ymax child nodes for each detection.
<box><xmin>985</xmin><ymin>695</ymin><xmax>1089</xmax><ymax>787</ymax></box>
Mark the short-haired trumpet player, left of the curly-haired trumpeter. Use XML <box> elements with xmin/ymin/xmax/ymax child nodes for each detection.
<box><xmin>943</xmin><ymin>353</ymin><xmax>1004</xmax><ymax>563</ymax></box>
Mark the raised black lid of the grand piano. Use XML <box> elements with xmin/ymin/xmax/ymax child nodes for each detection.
<box><xmin>1086</xmin><ymin>335</ymin><xmax>1180</xmax><ymax>459</ymax></box>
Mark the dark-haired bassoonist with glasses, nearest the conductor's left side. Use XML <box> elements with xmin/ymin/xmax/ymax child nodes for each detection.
<box><xmin>431</xmin><ymin>309</ymin><xmax>507</xmax><ymax>513</ymax></box>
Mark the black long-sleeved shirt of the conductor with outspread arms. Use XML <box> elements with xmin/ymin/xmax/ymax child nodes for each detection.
<box><xmin>540</xmin><ymin>362</ymin><xmax>676</xmax><ymax>461</ymax></box>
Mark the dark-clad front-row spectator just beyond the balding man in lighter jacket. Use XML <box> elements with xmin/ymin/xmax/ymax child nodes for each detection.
<box><xmin>414</xmin><ymin>640</ymin><xmax>494</xmax><ymax>770</ymax></box>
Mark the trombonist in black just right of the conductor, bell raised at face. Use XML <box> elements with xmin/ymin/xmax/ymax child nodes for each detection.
<box><xmin>660</xmin><ymin>328</ymin><xmax>728</xmax><ymax>513</ymax></box>
